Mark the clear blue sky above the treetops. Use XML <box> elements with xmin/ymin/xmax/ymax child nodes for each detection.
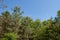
<box><xmin>0</xmin><ymin>0</ymin><xmax>60</xmax><ymax>20</ymax></box>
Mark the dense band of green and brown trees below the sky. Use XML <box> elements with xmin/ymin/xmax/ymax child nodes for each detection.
<box><xmin>0</xmin><ymin>7</ymin><xmax>60</xmax><ymax>40</ymax></box>
